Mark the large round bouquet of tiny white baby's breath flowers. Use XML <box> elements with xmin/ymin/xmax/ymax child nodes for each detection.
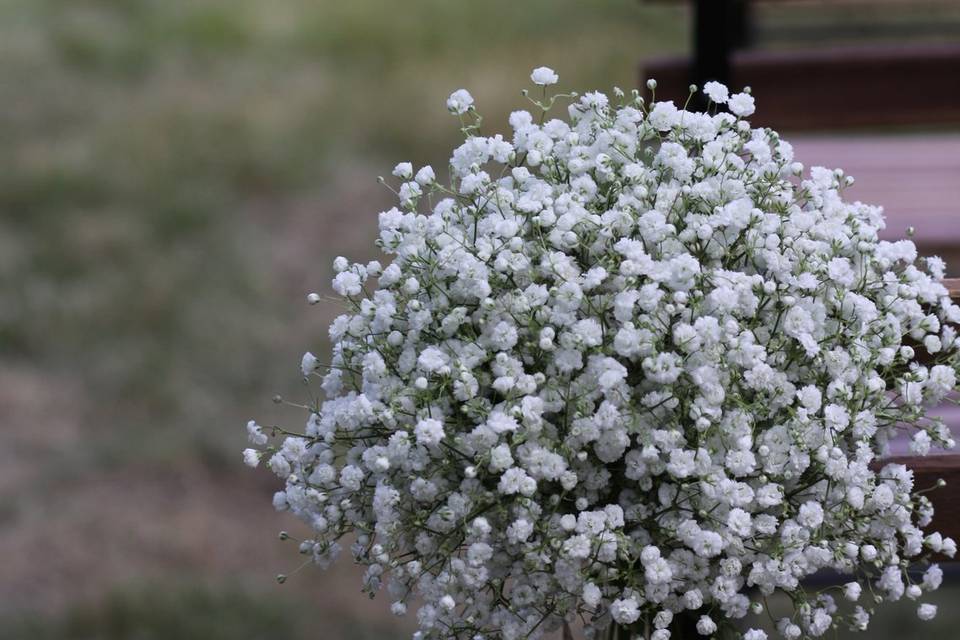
<box><xmin>245</xmin><ymin>68</ymin><xmax>960</xmax><ymax>640</ymax></box>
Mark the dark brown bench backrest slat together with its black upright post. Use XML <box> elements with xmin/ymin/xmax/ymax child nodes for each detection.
<box><xmin>641</xmin><ymin>0</ymin><xmax>960</xmax><ymax>130</ymax></box>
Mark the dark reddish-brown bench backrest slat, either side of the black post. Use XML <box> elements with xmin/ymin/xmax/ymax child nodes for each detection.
<box><xmin>643</xmin><ymin>44</ymin><xmax>960</xmax><ymax>130</ymax></box>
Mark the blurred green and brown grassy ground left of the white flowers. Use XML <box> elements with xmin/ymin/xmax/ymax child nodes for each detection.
<box><xmin>0</xmin><ymin>0</ymin><xmax>953</xmax><ymax>640</ymax></box>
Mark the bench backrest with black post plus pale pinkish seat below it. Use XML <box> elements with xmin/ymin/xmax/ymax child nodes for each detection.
<box><xmin>641</xmin><ymin>0</ymin><xmax>960</xmax><ymax>276</ymax></box>
